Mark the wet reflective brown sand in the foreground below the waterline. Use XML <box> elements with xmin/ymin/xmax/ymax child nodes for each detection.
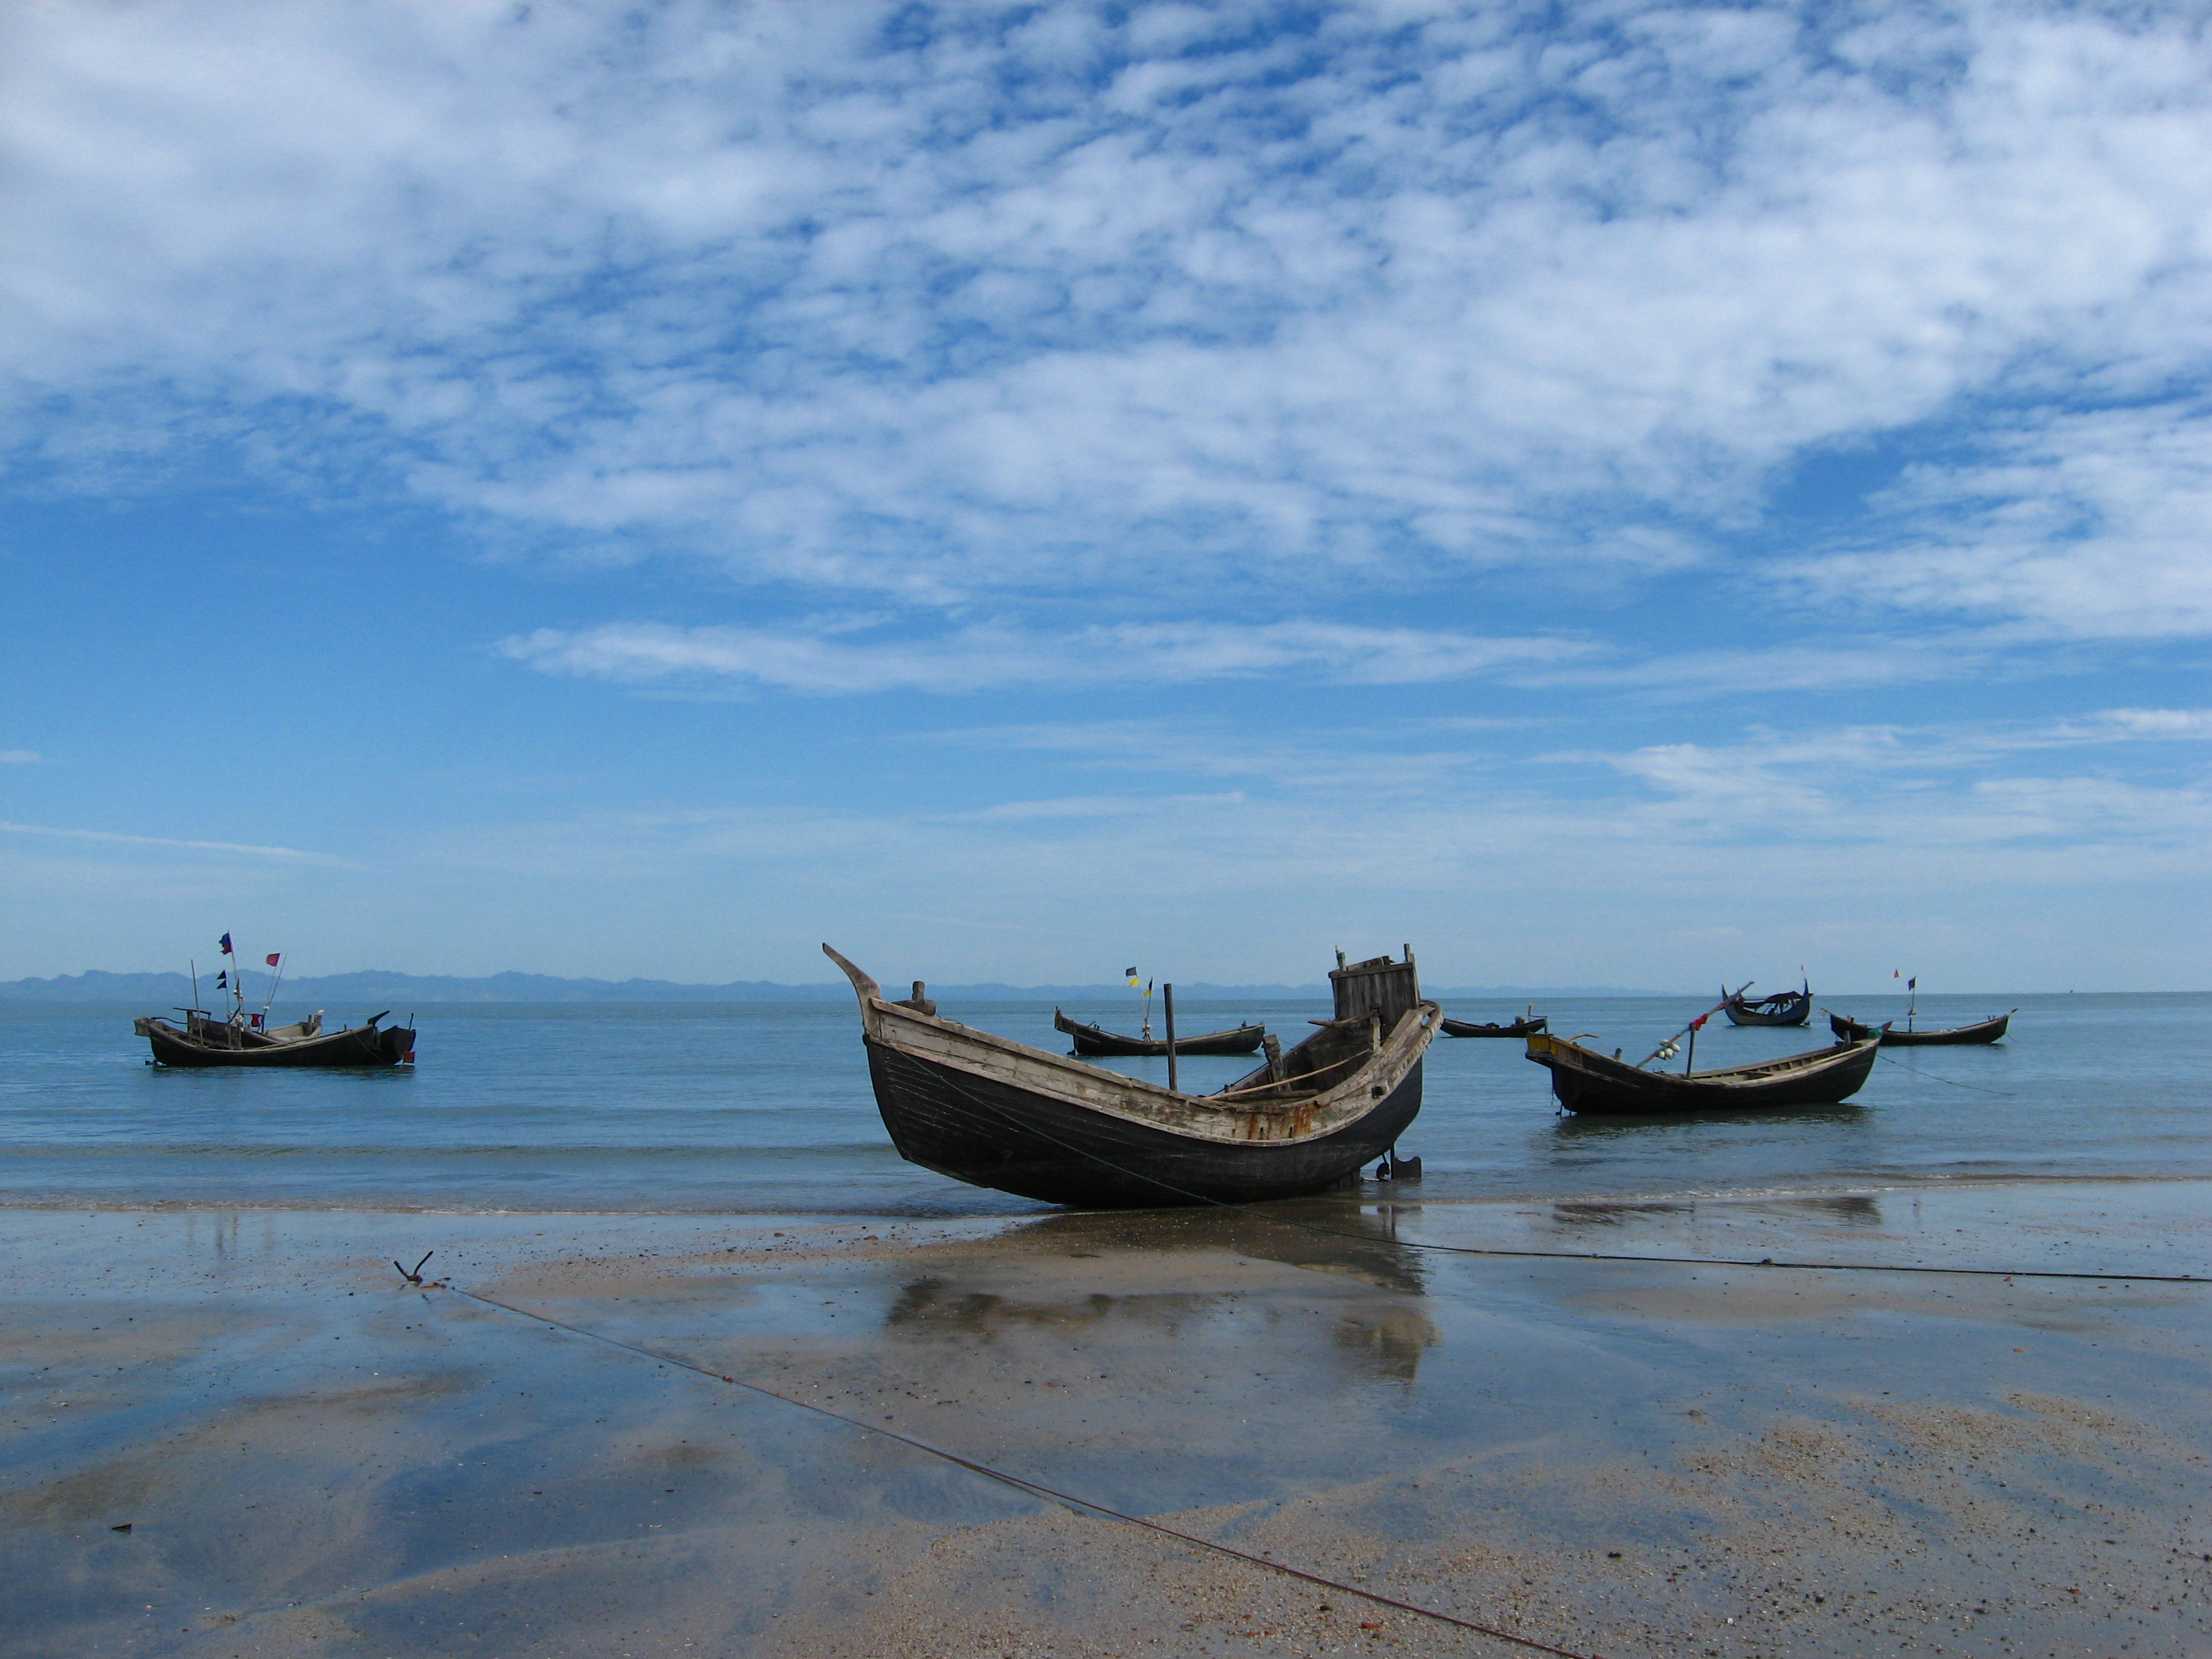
<box><xmin>0</xmin><ymin>1184</ymin><xmax>2212</xmax><ymax>1659</ymax></box>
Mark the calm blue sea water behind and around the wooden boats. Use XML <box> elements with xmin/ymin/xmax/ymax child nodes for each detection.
<box><xmin>0</xmin><ymin>993</ymin><xmax>2212</xmax><ymax>1215</ymax></box>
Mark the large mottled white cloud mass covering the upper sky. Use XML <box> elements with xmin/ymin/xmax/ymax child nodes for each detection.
<box><xmin>0</xmin><ymin>0</ymin><xmax>2212</xmax><ymax>637</ymax></box>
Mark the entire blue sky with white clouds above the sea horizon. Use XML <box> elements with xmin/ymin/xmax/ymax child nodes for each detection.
<box><xmin>0</xmin><ymin>0</ymin><xmax>2212</xmax><ymax>991</ymax></box>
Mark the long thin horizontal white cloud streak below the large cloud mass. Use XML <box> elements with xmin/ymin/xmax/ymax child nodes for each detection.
<box><xmin>498</xmin><ymin>621</ymin><xmax>1591</xmax><ymax>695</ymax></box>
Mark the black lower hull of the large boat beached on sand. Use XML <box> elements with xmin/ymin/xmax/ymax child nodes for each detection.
<box><xmin>867</xmin><ymin>1040</ymin><xmax>1420</xmax><ymax>1210</ymax></box>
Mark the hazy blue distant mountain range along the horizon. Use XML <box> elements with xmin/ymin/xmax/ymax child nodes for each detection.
<box><xmin>0</xmin><ymin>971</ymin><xmax>1663</xmax><ymax>1013</ymax></box>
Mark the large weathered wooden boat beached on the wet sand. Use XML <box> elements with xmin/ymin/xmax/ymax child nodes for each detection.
<box><xmin>823</xmin><ymin>945</ymin><xmax>1442</xmax><ymax>1208</ymax></box>
